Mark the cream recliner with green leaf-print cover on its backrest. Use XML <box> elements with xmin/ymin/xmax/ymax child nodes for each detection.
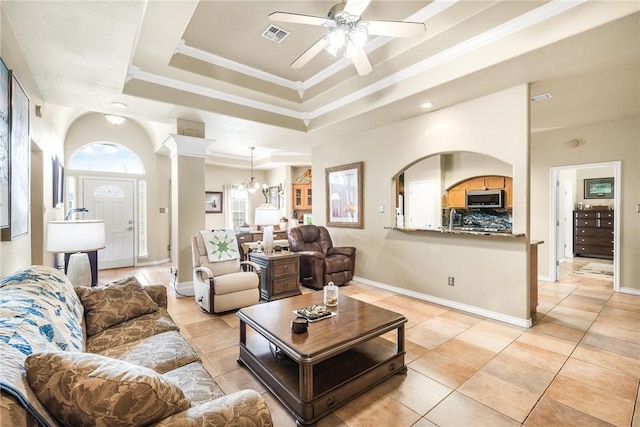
<box><xmin>191</xmin><ymin>230</ymin><xmax>260</xmax><ymax>313</ymax></box>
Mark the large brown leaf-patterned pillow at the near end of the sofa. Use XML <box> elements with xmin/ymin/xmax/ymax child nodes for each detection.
<box><xmin>25</xmin><ymin>351</ymin><xmax>191</xmax><ymax>427</ymax></box>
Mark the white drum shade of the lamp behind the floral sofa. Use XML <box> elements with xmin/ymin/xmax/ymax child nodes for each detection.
<box><xmin>47</xmin><ymin>221</ymin><xmax>106</xmax><ymax>253</ymax></box>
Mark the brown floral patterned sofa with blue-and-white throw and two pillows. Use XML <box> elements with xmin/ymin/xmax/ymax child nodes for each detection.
<box><xmin>0</xmin><ymin>266</ymin><xmax>273</xmax><ymax>427</ymax></box>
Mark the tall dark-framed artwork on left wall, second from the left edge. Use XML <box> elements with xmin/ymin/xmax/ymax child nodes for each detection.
<box><xmin>2</xmin><ymin>73</ymin><xmax>31</xmax><ymax>241</ymax></box>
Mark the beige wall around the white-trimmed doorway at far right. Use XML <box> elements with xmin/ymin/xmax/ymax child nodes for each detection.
<box><xmin>531</xmin><ymin>118</ymin><xmax>640</xmax><ymax>290</ymax></box>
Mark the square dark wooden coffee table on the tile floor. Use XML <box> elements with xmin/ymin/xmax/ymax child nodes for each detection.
<box><xmin>237</xmin><ymin>291</ymin><xmax>407</xmax><ymax>426</ymax></box>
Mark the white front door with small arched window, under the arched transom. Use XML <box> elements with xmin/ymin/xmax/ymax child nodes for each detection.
<box><xmin>82</xmin><ymin>178</ymin><xmax>135</xmax><ymax>269</ymax></box>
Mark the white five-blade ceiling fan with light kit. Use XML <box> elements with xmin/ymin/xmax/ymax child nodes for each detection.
<box><xmin>269</xmin><ymin>0</ymin><xmax>426</xmax><ymax>76</ymax></box>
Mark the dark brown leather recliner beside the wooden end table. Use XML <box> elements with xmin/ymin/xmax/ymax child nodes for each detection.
<box><xmin>287</xmin><ymin>224</ymin><xmax>356</xmax><ymax>289</ymax></box>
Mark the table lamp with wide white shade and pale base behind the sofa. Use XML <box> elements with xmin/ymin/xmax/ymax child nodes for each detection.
<box><xmin>46</xmin><ymin>220</ymin><xmax>106</xmax><ymax>286</ymax></box>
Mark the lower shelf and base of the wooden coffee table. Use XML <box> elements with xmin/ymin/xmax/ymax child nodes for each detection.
<box><xmin>238</xmin><ymin>333</ymin><xmax>407</xmax><ymax>426</ymax></box>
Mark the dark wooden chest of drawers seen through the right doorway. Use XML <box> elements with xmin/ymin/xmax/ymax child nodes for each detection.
<box><xmin>573</xmin><ymin>209</ymin><xmax>613</xmax><ymax>259</ymax></box>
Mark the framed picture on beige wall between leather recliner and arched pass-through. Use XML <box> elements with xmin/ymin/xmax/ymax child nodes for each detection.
<box><xmin>325</xmin><ymin>162</ymin><xmax>364</xmax><ymax>228</ymax></box>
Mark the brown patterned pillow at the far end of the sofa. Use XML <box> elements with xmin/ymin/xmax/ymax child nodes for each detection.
<box><xmin>75</xmin><ymin>276</ymin><xmax>158</xmax><ymax>336</ymax></box>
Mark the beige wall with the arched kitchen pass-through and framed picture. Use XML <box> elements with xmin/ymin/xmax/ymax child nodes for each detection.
<box><xmin>312</xmin><ymin>86</ymin><xmax>529</xmax><ymax>322</ymax></box>
